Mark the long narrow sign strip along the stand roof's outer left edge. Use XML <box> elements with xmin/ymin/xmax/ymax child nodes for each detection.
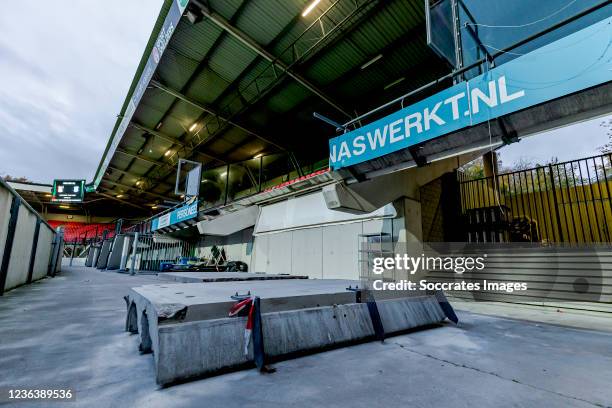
<box><xmin>94</xmin><ymin>0</ymin><xmax>189</xmax><ymax>189</ymax></box>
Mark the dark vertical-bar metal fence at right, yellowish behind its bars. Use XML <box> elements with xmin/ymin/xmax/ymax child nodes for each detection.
<box><xmin>459</xmin><ymin>153</ymin><xmax>612</xmax><ymax>243</ymax></box>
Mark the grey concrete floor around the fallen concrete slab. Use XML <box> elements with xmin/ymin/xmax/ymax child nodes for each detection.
<box><xmin>0</xmin><ymin>268</ymin><xmax>612</xmax><ymax>408</ymax></box>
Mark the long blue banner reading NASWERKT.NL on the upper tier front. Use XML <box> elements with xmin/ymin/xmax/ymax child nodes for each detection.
<box><xmin>329</xmin><ymin>18</ymin><xmax>612</xmax><ymax>170</ymax></box>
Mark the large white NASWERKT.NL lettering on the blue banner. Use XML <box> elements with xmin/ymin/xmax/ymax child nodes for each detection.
<box><xmin>329</xmin><ymin>76</ymin><xmax>525</xmax><ymax>163</ymax></box>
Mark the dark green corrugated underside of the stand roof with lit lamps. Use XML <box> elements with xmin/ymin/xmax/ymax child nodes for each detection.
<box><xmin>97</xmin><ymin>0</ymin><xmax>449</xmax><ymax>210</ymax></box>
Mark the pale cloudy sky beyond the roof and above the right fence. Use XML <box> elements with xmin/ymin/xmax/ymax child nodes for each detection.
<box><xmin>0</xmin><ymin>0</ymin><xmax>607</xmax><ymax>183</ymax></box>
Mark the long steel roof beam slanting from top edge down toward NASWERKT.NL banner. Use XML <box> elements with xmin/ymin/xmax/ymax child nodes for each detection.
<box><xmin>191</xmin><ymin>0</ymin><xmax>352</xmax><ymax>118</ymax></box>
